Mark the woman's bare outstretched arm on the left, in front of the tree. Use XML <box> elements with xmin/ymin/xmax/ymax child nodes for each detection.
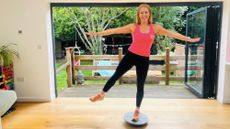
<box><xmin>86</xmin><ymin>24</ymin><xmax>135</xmax><ymax>36</ymax></box>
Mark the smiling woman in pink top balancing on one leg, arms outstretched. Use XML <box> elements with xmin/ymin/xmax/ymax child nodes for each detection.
<box><xmin>86</xmin><ymin>4</ymin><xmax>200</xmax><ymax>121</ymax></box>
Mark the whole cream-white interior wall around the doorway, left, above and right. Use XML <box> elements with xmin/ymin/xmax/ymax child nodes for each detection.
<box><xmin>0</xmin><ymin>0</ymin><xmax>230</xmax><ymax>102</ymax></box>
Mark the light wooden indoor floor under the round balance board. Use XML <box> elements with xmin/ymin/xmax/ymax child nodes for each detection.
<box><xmin>2</xmin><ymin>98</ymin><xmax>230</xmax><ymax>129</ymax></box>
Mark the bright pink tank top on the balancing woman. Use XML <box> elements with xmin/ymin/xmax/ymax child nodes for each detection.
<box><xmin>128</xmin><ymin>24</ymin><xmax>155</xmax><ymax>57</ymax></box>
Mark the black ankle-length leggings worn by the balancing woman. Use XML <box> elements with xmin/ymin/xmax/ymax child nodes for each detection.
<box><xmin>103</xmin><ymin>52</ymin><xmax>149</xmax><ymax>107</ymax></box>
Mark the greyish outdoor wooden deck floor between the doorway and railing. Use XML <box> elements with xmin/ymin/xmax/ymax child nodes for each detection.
<box><xmin>58</xmin><ymin>84</ymin><xmax>197</xmax><ymax>99</ymax></box>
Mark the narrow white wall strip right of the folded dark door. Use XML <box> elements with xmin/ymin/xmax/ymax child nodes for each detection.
<box><xmin>217</xmin><ymin>0</ymin><xmax>230</xmax><ymax>103</ymax></box>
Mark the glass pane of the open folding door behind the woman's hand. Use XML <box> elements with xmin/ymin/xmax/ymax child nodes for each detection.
<box><xmin>186</xmin><ymin>10</ymin><xmax>206</xmax><ymax>94</ymax></box>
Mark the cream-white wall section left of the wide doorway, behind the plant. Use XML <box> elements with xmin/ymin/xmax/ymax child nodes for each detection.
<box><xmin>0</xmin><ymin>0</ymin><xmax>54</xmax><ymax>101</ymax></box>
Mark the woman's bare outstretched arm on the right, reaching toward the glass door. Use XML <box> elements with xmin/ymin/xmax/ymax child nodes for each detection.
<box><xmin>154</xmin><ymin>24</ymin><xmax>200</xmax><ymax>42</ymax></box>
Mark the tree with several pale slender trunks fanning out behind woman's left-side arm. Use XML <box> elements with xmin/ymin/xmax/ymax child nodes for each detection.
<box><xmin>65</xmin><ymin>7</ymin><xmax>128</xmax><ymax>55</ymax></box>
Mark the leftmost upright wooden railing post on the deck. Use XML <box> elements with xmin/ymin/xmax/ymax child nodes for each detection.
<box><xmin>66</xmin><ymin>47</ymin><xmax>75</xmax><ymax>87</ymax></box>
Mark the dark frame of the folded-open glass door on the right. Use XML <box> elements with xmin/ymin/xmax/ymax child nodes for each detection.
<box><xmin>185</xmin><ymin>5</ymin><xmax>223</xmax><ymax>98</ymax></box>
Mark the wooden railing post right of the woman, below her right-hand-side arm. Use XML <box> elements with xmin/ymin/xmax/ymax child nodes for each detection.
<box><xmin>165</xmin><ymin>48</ymin><xmax>170</xmax><ymax>85</ymax></box>
